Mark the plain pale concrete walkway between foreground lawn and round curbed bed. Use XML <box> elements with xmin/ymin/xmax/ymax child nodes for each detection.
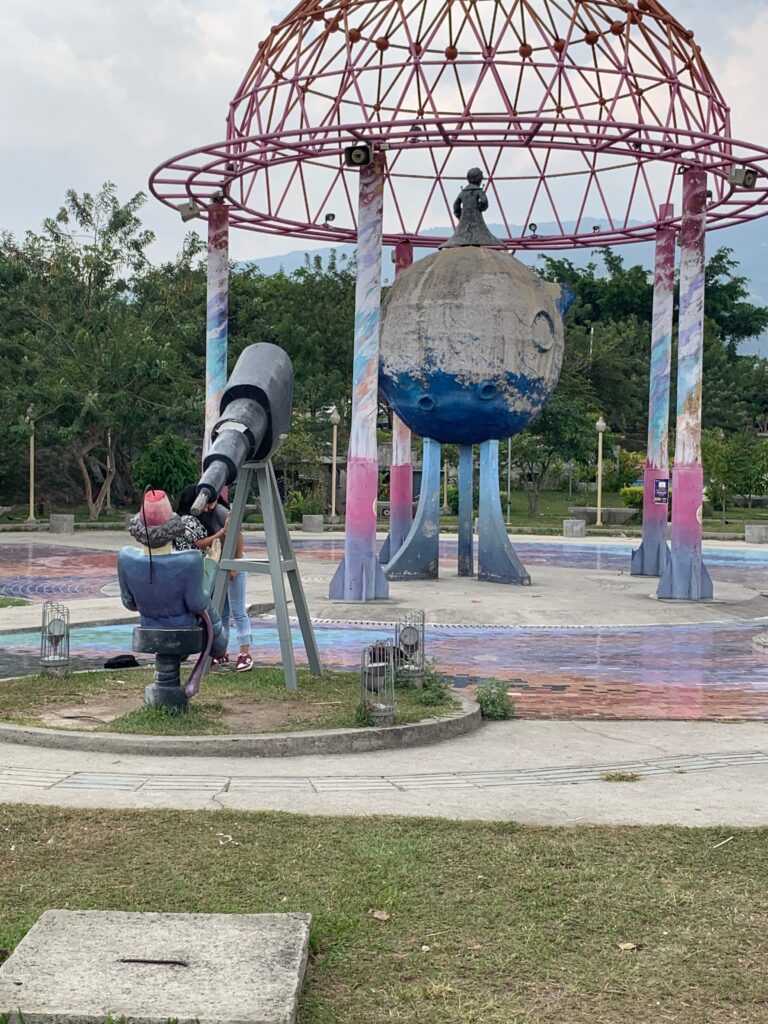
<box><xmin>0</xmin><ymin>721</ymin><xmax>768</xmax><ymax>826</ymax></box>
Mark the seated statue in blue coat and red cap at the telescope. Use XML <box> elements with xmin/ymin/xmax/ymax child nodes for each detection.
<box><xmin>118</xmin><ymin>488</ymin><xmax>228</xmax><ymax>696</ymax></box>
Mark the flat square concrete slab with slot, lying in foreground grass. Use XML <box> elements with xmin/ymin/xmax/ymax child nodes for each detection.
<box><xmin>0</xmin><ymin>910</ymin><xmax>311</xmax><ymax>1024</ymax></box>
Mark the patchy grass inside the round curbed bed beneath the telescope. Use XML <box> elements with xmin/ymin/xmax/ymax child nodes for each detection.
<box><xmin>0</xmin><ymin>668</ymin><xmax>456</xmax><ymax>735</ymax></box>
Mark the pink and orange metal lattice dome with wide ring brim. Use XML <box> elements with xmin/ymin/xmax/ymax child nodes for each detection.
<box><xmin>151</xmin><ymin>0</ymin><xmax>768</xmax><ymax>249</ymax></box>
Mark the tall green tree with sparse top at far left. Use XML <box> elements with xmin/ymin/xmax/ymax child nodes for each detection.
<box><xmin>0</xmin><ymin>182</ymin><xmax>193</xmax><ymax>519</ymax></box>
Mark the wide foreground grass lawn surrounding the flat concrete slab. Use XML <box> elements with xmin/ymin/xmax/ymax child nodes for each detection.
<box><xmin>0</xmin><ymin>806</ymin><xmax>768</xmax><ymax>1024</ymax></box>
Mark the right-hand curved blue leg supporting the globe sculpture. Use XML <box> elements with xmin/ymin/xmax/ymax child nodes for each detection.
<box><xmin>477</xmin><ymin>440</ymin><xmax>530</xmax><ymax>587</ymax></box>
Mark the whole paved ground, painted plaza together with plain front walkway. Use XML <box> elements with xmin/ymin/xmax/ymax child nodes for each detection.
<box><xmin>0</xmin><ymin>531</ymin><xmax>768</xmax><ymax>825</ymax></box>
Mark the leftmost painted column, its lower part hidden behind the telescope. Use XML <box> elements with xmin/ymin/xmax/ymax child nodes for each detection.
<box><xmin>203</xmin><ymin>203</ymin><xmax>229</xmax><ymax>453</ymax></box>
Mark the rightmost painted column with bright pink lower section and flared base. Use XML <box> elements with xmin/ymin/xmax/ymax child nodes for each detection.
<box><xmin>657</xmin><ymin>168</ymin><xmax>712</xmax><ymax>601</ymax></box>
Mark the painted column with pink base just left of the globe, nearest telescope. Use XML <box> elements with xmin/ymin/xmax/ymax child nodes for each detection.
<box><xmin>330</xmin><ymin>153</ymin><xmax>389</xmax><ymax>601</ymax></box>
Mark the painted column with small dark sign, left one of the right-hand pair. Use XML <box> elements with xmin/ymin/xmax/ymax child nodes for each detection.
<box><xmin>631</xmin><ymin>205</ymin><xmax>676</xmax><ymax>577</ymax></box>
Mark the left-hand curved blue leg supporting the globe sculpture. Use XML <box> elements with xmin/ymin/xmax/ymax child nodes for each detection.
<box><xmin>385</xmin><ymin>437</ymin><xmax>441</xmax><ymax>580</ymax></box>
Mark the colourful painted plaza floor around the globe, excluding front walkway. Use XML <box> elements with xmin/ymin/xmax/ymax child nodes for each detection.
<box><xmin>0</xmin><ymin>532</ymin><xmax>768</xmax><ymax>721</ymax></box>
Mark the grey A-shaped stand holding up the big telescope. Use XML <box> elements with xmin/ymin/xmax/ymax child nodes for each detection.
<box><xmin>213</xmin><ymin>459</ymin><xmax>323</xmax><ymax>690</ymax></box>
